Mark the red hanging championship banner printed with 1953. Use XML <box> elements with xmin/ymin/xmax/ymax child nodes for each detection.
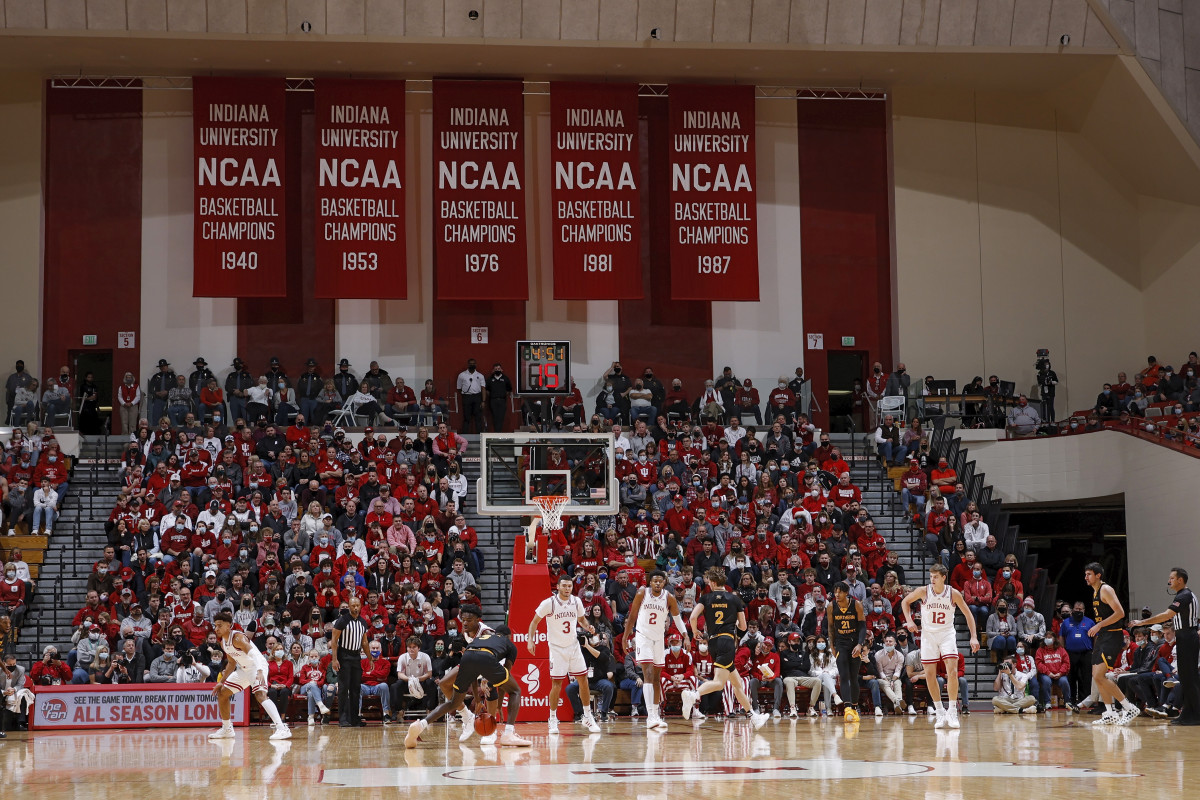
<box><xmin>313</xmin><ymin>78</ymin><xmax>408</xmax><ymax>300</ymax></box>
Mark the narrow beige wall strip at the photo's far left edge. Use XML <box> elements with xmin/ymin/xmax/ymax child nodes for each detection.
<box><xmin>0</xmin><ymin>74</ymin><xmax>42</xmax><ymax>388</ymax></box>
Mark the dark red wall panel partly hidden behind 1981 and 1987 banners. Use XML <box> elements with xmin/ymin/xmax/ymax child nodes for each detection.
<box><xmin>619</xmin><ymin>97</ymin><xmax>713</xmax><ymax>402</ymax></box>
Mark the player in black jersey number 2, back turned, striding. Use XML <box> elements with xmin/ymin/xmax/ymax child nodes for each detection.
<box><xmin>680</xmin><ymin>566</ymin><xmax>770</xmax><ymax>728</ymax></box>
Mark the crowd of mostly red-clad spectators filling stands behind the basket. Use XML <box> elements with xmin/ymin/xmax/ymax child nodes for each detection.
<box><xmin>6</xmin><ymin>352</ymin><xmax>1180</xmax><ymax>722</ymax></box>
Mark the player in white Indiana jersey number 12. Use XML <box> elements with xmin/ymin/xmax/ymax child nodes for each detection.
<box><xmin>900</xmin><ymin>564</ymin><xmax>979</xmax><ymax>728</ymax></box>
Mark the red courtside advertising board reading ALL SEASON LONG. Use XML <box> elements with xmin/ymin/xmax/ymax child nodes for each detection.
<box><xmin>29</xmin><ymin>684</ymin><xmax>250</xmax><ymax>730</ymax></box>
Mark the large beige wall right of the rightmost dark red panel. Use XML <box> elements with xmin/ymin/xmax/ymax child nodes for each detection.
<box><xmin>893</xmin><ymin>89</ymin><xmax>1147</xmax><ymax>414</ymax></box>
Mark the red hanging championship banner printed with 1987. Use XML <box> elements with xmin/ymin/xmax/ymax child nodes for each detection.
<box><xmin>670</xmin><ymin>84</ymin><xmax>758</xmax><ymax>300</ymax></box>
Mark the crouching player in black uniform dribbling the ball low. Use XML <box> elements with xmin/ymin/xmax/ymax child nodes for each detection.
<box><xmin>404</xmin><ymin>604</ymin><xmax>533</xmax><ymax>750</ymax></box>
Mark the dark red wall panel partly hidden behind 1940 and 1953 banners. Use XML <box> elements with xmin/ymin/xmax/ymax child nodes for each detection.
<box><xmin>236</xmin><ymin>91</ymin><xmax>336</xmax><ymax>379</ymax></box>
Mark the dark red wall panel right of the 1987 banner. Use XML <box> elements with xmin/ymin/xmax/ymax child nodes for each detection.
<box><xmin>797</xmin><ymin>100</ymin><xmax>892</xmax><ymax>427</ymax></box>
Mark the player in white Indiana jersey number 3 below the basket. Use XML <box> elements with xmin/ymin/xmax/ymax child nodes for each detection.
<box><xmin>527</xmin><ymin>575</ymin><xmax>600</xmax><ymax>733</ymax></box>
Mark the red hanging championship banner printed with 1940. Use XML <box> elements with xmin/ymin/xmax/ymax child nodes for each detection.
<box><xmin>192</xmin><ymin>77</ymin><xmax>287</xmax><ymax>297</ymax></box>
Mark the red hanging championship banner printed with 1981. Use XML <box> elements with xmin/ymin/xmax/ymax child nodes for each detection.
<box><xmin>550</xmin><ymin>83</ymin><xmax>642</xmax><ymax>300</ymax></box>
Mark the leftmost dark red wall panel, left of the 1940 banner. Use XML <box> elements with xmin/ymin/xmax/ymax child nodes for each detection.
<box><xmin>44</xmin><ymin>88</ymin><xmax>145</xmax><ymax>424</ymax></box>
